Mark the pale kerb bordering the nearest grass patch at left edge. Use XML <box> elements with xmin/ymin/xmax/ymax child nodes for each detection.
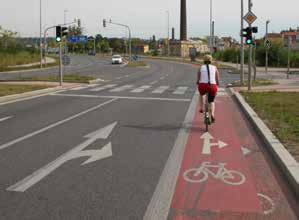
<box><xmin>0</xmin><ymin>86</ymin><xmax>77</xmax><ymax>105</ymax></box>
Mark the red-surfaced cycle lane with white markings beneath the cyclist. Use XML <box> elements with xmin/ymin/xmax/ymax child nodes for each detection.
<box><xmin>168</xmin><ymin>96</ymin><xmax>297</xmax><ymax>220</ymax></box>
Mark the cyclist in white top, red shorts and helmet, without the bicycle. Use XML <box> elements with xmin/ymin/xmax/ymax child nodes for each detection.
<box><xmin>197</xmin><ymin>55</ymin><xmax>219</xmax><ymax>123</ymax></box>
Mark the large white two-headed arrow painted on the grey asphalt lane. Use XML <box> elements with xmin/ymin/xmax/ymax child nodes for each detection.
<box><xmin>6</xmin><ymin>122</ymin><xmax>117</xmax><ymax>192</ymax></box>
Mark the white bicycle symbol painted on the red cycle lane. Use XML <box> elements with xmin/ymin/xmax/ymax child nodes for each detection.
<box><xmin>183</xmin><ymin>162</ymin><xmax>246</xmax><ymax>185</ymax></box>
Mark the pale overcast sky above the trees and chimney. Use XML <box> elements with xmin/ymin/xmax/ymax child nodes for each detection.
<box><xmin>0</xmin><ymin>0</ymin><xmax>299</xmax><ymax>39</ymax></box>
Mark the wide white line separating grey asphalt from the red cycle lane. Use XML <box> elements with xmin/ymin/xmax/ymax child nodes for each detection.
<box><xmin>143</xmin><ymin>91</ymin><xmax>198</xmax><ymax>220</ymax></box>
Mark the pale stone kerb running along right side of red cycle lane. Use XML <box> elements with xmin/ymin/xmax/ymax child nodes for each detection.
<box><xmin>229</xmin><ymin>88</ymin><xmax>299</xmax><ymax>197</ymax></box>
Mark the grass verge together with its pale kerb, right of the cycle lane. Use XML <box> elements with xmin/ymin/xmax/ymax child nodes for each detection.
<box><xmin>230</xmin><ymin>88</ymin><xmax>299</xmax><ymax>197</ymax></box>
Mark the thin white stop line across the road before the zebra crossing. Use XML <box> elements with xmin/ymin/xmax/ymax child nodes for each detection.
<box><xmin>50</xmin><ymin>93</ymin><xmax>190</xmax><ymax>102</ymax></box>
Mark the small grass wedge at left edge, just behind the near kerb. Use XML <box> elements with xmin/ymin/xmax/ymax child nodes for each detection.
<box><xmin>0</xmin><ymin>84</ymin><xmax>49</xmax><ymax>97</ymax></box>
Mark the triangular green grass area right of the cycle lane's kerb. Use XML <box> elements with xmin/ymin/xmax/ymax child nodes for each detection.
<box><xmin>241</xmin><ymin>91</ymin><xmax>299</xmax><ymax>162</ymax></box>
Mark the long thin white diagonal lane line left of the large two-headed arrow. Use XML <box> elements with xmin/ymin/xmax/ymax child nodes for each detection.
<box><xmin>0</xmin><ymin>98</ymin><xmax>117</xmax><ymax>150</ymax></box>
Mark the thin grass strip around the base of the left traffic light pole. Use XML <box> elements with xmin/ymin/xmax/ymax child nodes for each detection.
<box><xmin>10</xmin><ymin>74</ymin><xmax>96</xmax><ymax>83</ymax></box>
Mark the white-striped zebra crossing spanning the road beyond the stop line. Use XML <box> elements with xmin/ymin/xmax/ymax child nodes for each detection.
<box><xmin>69</xmin><ymin>84</ymin><xmax>226</xmax><ymax>96</ymax></box>
